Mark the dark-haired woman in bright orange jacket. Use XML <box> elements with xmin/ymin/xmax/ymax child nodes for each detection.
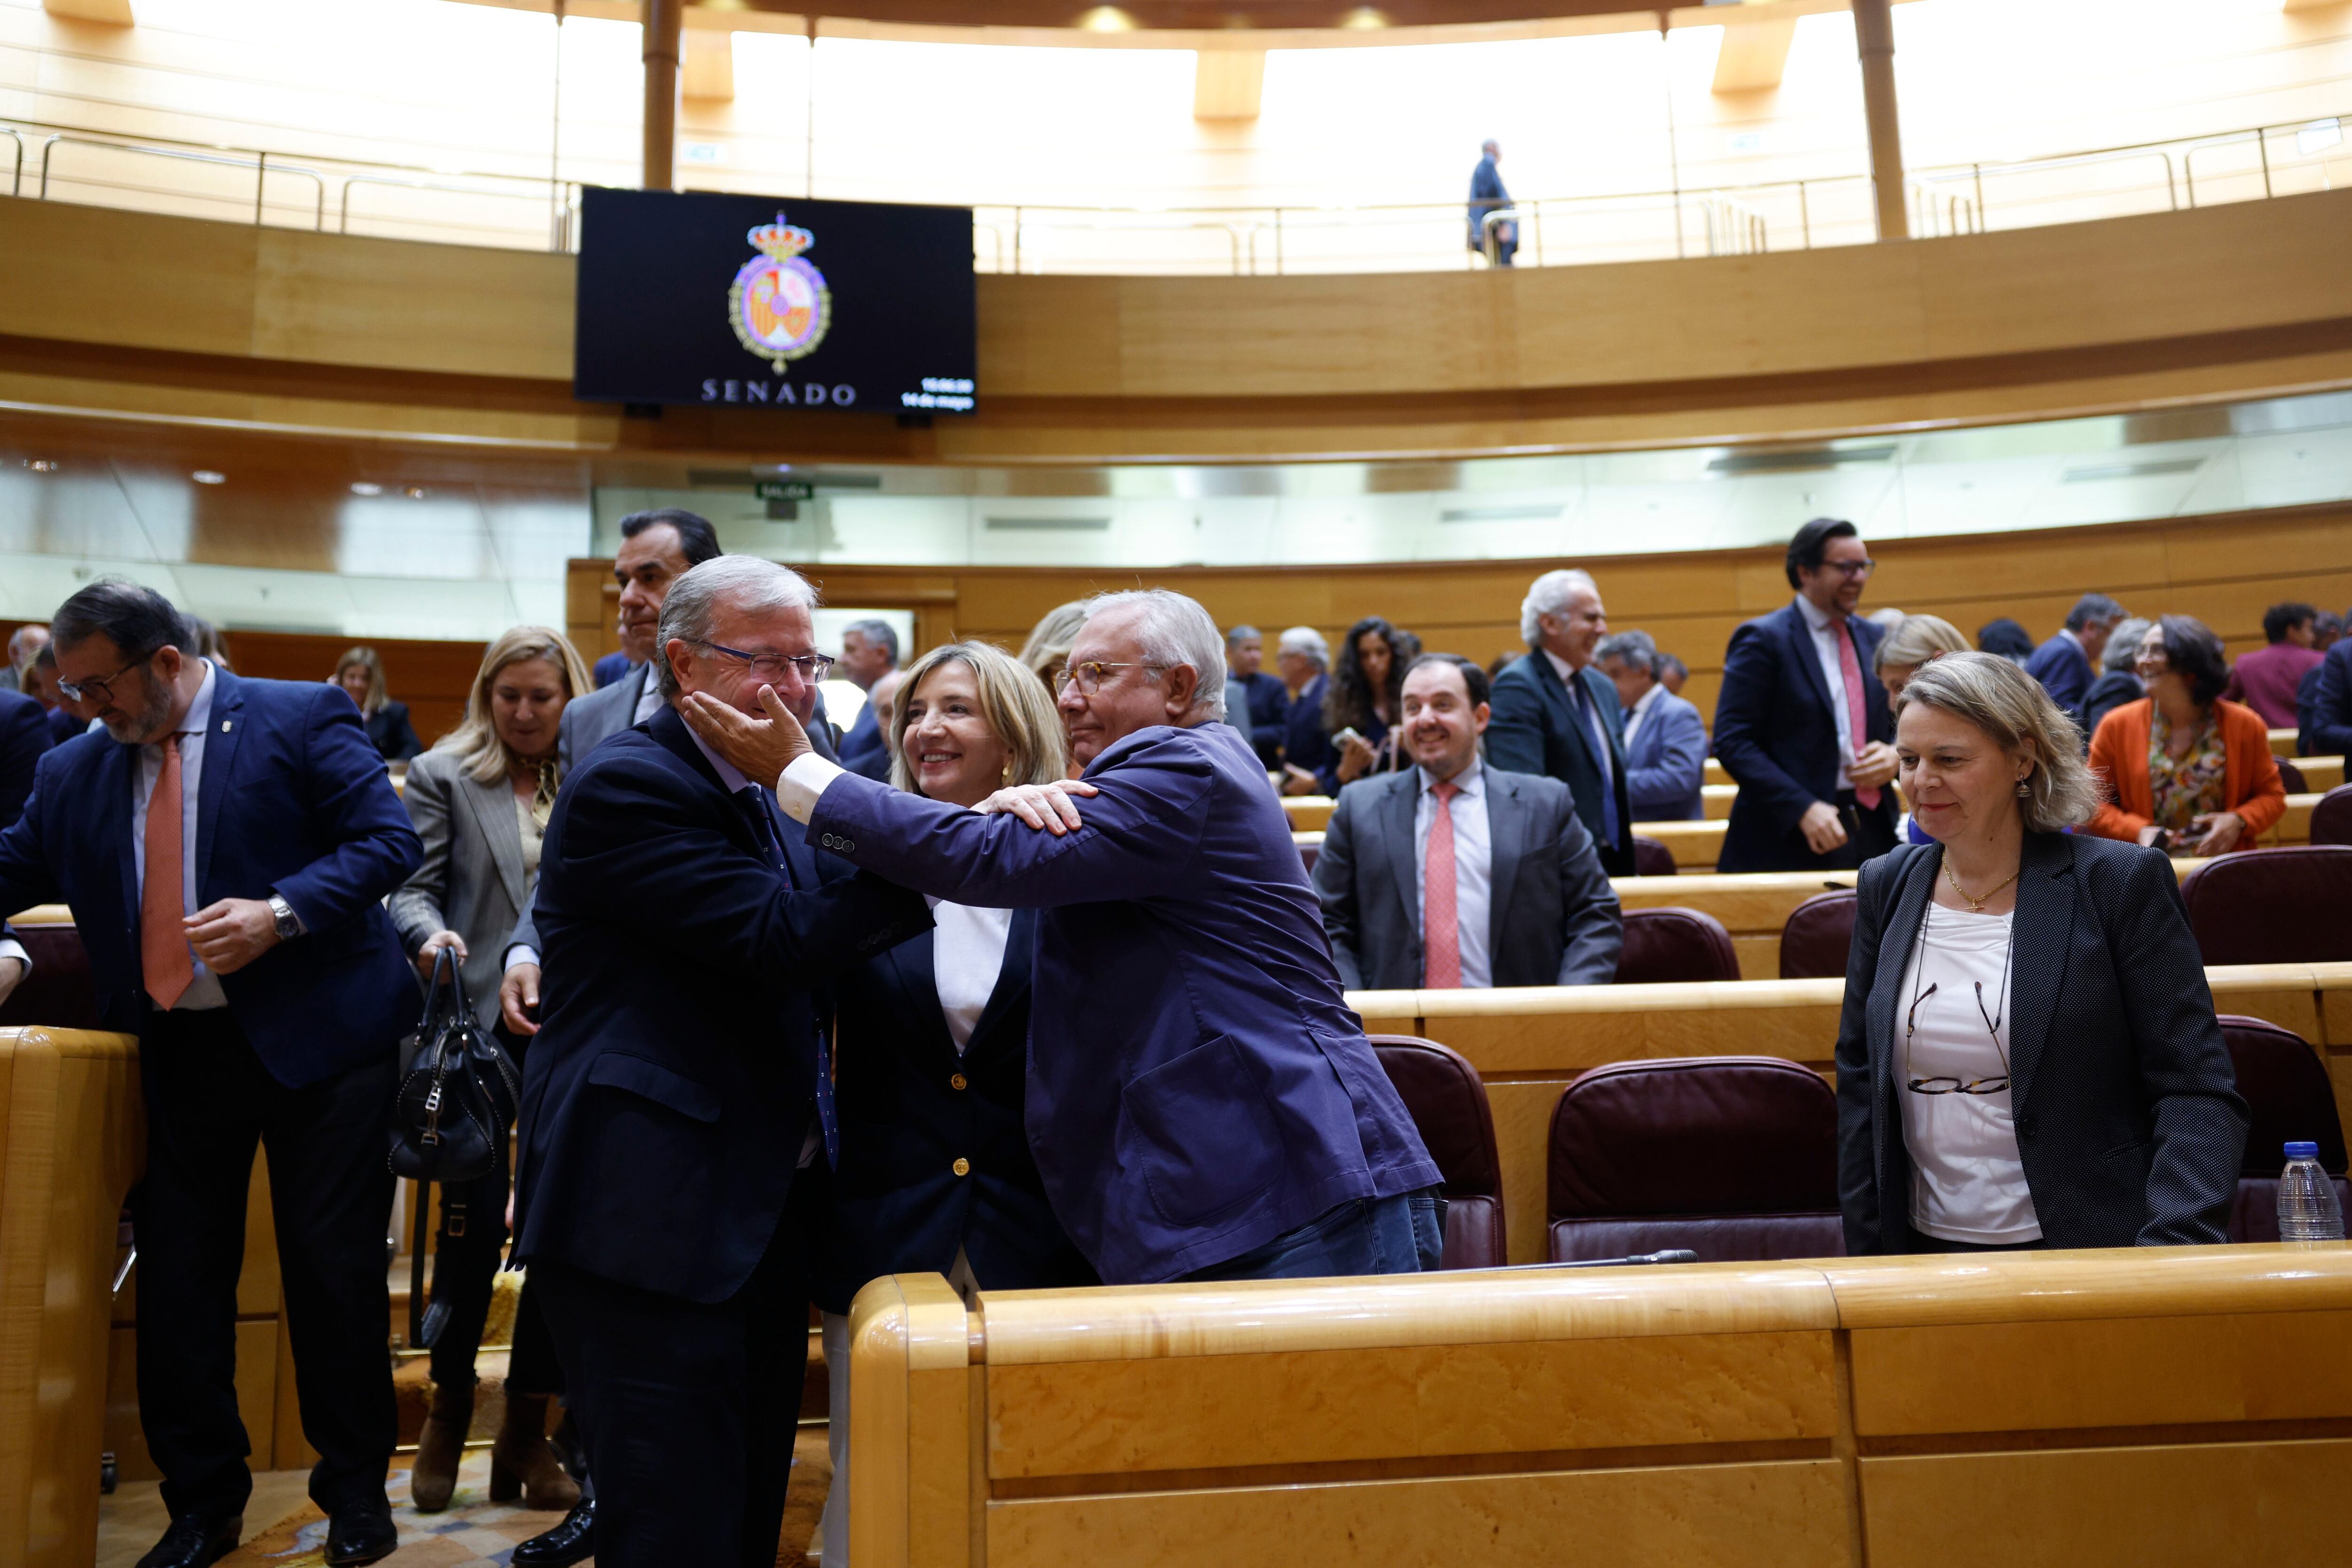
<box><xmin>2091</xmin><ymin>616</ymin><xmax>2286</xmax><ymax>855</ymax></box>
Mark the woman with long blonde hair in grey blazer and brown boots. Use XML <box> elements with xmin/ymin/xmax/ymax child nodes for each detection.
<box><xmin>390</xmin><ymin>626</ymin><xmax>588</xmax><ymax>1514</ymax></box>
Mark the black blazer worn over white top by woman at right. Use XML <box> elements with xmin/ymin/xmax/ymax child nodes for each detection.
<box><xmin>1837</xmin><ymin>832</ymin><xmax>2246</xmax><ymax>1255</ymax></box>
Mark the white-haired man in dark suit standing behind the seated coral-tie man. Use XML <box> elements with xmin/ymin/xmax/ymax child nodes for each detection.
<box><xmin>1486</xmin><ymin>569</ymin><xmax>1632</xmax><ymax>877</ymax></box>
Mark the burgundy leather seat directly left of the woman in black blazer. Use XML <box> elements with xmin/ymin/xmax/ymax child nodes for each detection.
<box><xmin>1548</xmin><ymin>1055</ymin><xmax>1846</xmax><ymax>1262</ymax></box>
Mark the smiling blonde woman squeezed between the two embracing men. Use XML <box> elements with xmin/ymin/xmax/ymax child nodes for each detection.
<box><xmin>800</xmin><ymin>642</ymin><xmax>1096</xmax><ymax>1568</ymax></box>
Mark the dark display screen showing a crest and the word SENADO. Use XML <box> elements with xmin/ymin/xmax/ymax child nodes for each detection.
<box><xmin>572</xmin><ymin>188</ymin><xmax>978</xmax><ymax>414</ymax></box>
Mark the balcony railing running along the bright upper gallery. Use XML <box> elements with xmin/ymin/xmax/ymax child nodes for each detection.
<box><xmin>0</xmin><ymin>118</ymin><xmax>2352</xmax><ymax>275</ymax></box>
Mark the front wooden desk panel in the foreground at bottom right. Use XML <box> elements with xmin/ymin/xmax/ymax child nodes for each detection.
<box><xmin>849</xmin><ymin>1243</ymin><xmax>2352</xmax><ymax>1568</ymax></box>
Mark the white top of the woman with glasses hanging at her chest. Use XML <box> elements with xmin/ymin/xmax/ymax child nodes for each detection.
<box><xmin>1893</xmin><ymin>905</ymin><xmax>2042</xmax><ymax>1246</ymax></box>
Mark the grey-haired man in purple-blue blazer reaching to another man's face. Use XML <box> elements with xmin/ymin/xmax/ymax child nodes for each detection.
<box><xmin>687</xmin><ymin>590</ymin><xmax>1444</xmax><ymax>1283</ymax></box>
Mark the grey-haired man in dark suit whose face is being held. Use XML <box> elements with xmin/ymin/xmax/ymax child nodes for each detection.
<box><xmin>515</xmin><ymin>555</ymin><xmax>931</xmax><ymax>1568</ymax></box>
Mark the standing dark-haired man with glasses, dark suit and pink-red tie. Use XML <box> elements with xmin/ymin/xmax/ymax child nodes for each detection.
<box><xmin>1715</xmin><ymin>517</ymin><xmax>1896</xmax><ymax>872</ymax></box>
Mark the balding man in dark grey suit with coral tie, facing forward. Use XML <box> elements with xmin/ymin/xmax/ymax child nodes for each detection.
<box><xmin>1315</xmin><ymin>654</ymin><xmax>1625</xmax><ymax>990</ymax></box>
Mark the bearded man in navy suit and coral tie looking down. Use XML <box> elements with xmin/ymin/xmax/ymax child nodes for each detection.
<box><xmin>0</xmin><ymin>578</ymin><xmax>423</xmax><ymax>1568</ymax></box>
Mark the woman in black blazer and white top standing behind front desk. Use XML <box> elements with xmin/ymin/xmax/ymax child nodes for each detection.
<box><xmin>1837</xmin><ymin>654</ymin><xmax>2246</xmax><ymax>1253</ymax></box>
